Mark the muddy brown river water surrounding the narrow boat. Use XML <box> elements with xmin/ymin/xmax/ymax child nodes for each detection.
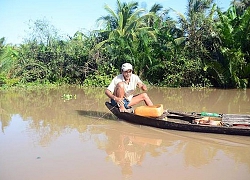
<box><xmin>0</xmin><ymin>87</ymin><xmax>250</xmax><ymax>180</ymax></box>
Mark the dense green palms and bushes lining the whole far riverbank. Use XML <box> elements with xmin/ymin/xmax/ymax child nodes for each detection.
<box><xmin>0</xmin><ymin>0</ymin><xmax>250</xmax><ymax>88</ymax></box>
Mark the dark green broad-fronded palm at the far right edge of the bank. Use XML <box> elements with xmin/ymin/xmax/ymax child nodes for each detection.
<box><xmin>207</xmin><ymin>6</ymin><xmax>250</xmax><ymax>88</ymax></box>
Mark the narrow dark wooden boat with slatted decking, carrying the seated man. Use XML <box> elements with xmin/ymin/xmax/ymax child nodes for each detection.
<box><xmin>105</xmin><ymin>102</ymin><xmax>250</xmax><ymax>136</ymax></box>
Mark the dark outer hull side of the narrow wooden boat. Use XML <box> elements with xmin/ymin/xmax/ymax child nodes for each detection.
<box><xmin>105</xmin><ymin>102</ymin><xmax>250</xmax><ymax>136</ymax></box>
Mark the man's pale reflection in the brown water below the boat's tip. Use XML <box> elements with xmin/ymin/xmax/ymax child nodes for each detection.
<box><xmin>105</xmin><ymin>124</ymin><xmax>162</xmax><ymax>175</ymax></box>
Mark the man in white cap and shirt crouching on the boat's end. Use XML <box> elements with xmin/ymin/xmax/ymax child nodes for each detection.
<box><xmin>105</xmin><ymin>63</ymin><xmax>153</xmax><ymax>112</ymax></box>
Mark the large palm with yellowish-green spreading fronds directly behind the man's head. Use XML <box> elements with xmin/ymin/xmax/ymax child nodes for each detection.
<box><xmin>96</xmin><ymin>0</ymin><xmax>154</xmax><ymax>73</ymax></box>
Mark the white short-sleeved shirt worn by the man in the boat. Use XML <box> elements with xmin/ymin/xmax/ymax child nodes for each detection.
<box><xmin>107</xmin><ymin>74</ymin><xmax>142</xmax><ymax>101</ymax></box>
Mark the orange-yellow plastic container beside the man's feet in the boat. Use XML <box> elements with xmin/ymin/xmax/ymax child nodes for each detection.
<box><xmin>134</xmin><ymin>104</ymin><xmax>163</xmax><ymax>117</ymax></box>
